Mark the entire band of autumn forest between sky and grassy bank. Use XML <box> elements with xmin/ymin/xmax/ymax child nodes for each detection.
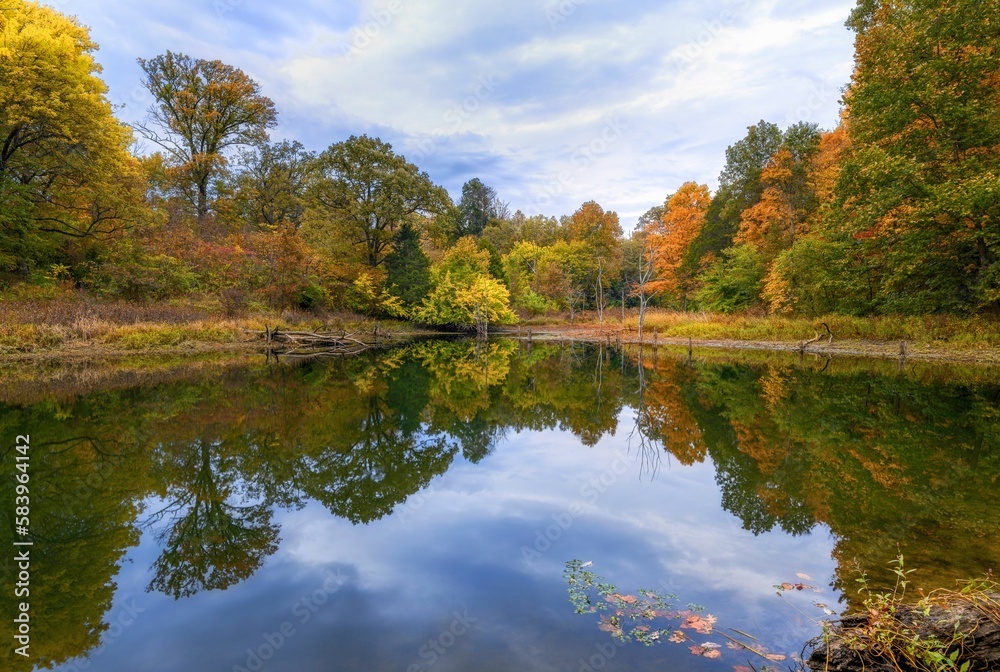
<box><xmin>0</xmin><ymin>0</ymin><xmax>1000</xmax><ymax>326</ymax></box>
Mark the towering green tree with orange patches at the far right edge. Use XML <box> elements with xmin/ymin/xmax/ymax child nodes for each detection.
<box><xmin>836</xmin><ymin>0</ymin><xmax>1000</xmax><ymax>313</ymax></box>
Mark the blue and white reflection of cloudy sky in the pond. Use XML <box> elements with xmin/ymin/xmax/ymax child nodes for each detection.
<box><xmin>60</xmin><ymin>418</ymin><xmax>831</xmax><ymax>672</ymax></box>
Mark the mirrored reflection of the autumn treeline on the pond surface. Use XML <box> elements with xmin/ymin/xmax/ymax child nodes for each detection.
<box><xmin>0</xmin><ymin>341</ymin><xmax>1000</xmax><ymax>670</ymax></box>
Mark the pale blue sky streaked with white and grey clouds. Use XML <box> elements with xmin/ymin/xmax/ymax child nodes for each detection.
<box><xmin>46</xmin><ymin>0</ymin><xmax>854</xmax><ymax>230</ymax></box>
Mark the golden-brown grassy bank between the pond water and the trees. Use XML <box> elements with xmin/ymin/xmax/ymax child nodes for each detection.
<box><xmin>0</xmin><ymin>291</ymin><xmax>1000</xmax><ymax>362</ymax></box>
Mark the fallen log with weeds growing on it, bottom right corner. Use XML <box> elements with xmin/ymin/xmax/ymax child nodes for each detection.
<box><xmin>806</xmin><ymin>593</ymin><xmax>1000</xmax><ymax>672</ymax></box>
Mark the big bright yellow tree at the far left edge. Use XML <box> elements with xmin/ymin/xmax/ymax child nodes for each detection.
<box><xmin>0</xmin><ymin>0</ymin><xmax>144</xmax><ymax>273</ymax></box>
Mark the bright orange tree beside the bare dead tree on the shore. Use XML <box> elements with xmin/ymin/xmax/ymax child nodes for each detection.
<box><xmin>649</xmin><ymin>182</ymin><xmax>711</xmax><ymax>309</ymax></box>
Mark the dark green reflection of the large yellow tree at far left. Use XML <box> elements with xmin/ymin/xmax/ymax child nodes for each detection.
<box><xmin>0</xmin><ymin>402</ymin><xmax>149</xmax><ymax>672</ymax></box>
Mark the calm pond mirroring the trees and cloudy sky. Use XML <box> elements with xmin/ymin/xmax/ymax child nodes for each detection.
<box><xmin>0</xmin><ymin>339</ymin><xmax>1000</xmax><ymax>672</ymax></box>
